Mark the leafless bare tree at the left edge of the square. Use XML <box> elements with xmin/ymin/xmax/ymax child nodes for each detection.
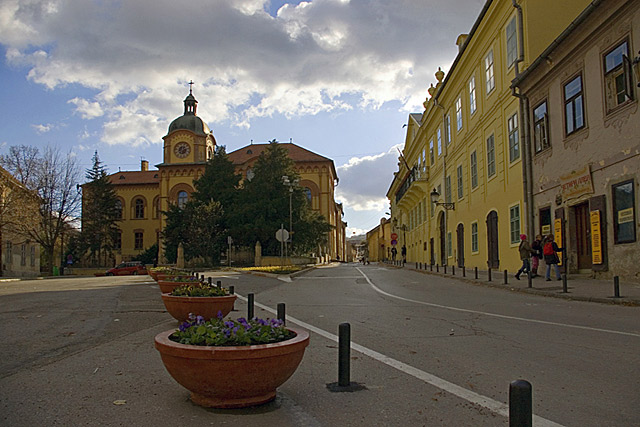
<box><xmin>0</xmin><ymin>146</ymin><xmax>81</xmax><ymax>273</ymax></box>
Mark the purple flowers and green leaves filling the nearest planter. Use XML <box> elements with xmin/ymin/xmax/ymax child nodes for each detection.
<box><xmin>169</xmin><ymin>316</ymin><xmax>296</xmax><ymax>346</ymax></box>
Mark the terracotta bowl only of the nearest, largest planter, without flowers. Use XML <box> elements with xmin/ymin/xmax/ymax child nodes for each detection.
<box><xmin>155</xmin><ymin>328</ymin><xmax>309</xmax><ymax>408</ymax></box>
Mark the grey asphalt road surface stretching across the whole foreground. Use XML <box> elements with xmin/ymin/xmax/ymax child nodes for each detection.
<box><xmin>0</xmin><ymin>264</ymin><xmax>640</xmax><ymax>426</ymax></box>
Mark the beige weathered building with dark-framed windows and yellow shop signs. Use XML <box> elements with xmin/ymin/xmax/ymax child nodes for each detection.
<box><xmin>513</xmin><ymin>0</ymin><xmax>640</xmax><ymax>280</ymax></box>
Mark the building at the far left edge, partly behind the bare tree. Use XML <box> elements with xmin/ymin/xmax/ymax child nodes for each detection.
<box><xmin>0</xmin><ymin>167</ymin><xmax>40</xmax><ymax>277</ymax></box>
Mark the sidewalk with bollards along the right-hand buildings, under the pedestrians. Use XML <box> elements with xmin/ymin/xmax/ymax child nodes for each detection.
<box><xmin>382</xmin><ymin>262</ymin><xmax>640</xmax><ymax>306</ymax></box>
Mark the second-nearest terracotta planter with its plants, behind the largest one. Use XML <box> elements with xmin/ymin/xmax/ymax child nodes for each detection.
<box><xmin>162</xmin><ymin>282</ymin><xmax>237</xmax><ymax>322</ymax></box>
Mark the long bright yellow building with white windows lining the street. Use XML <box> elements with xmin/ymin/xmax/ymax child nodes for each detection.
<box><xmin>387</xmin><ymin>0</ymin><xmax>590</xmax><ymax>270</ymax></box>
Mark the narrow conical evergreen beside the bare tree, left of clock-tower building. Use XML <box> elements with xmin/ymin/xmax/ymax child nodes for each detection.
<box><xmin>81</xmin><ymin>151</ymin><xmax>122</xmax><ymax>264</ymax></box>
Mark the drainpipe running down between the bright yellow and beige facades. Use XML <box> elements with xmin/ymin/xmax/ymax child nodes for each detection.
<box><xmin>511</xmin><ymin>0</ymin><xmax>535</xmax><ymax>238</ymax></box>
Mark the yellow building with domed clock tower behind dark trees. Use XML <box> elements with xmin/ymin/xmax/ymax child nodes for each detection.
<box><xmin>109</xmin><ymin>91</ymin><xmax>346</xmax><ymax>263</ymax></box>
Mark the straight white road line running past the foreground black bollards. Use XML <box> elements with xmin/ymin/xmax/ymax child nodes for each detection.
<box><xmin>236</xmin><ymin>296</ymin><xmax>563</xmax><ymax>427</ymax></box>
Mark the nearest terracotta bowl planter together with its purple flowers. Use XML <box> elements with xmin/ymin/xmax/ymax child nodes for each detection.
<box><xmin>155</xmin><ymin>313</ymin><xmax>309</xmax><ymax>408</ymax></box>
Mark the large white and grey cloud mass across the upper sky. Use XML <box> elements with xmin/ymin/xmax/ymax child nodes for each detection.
<box><xmin>0</xmin><ymin>0</ymin><xmax>484</xmax><ymax>145</ymax></box>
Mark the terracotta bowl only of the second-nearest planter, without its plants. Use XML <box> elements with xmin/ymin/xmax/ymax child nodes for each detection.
<box><xmin>162</xmin><ymin>293</ymin><xmax>237</xmax><ymax>322</ymax></box>
